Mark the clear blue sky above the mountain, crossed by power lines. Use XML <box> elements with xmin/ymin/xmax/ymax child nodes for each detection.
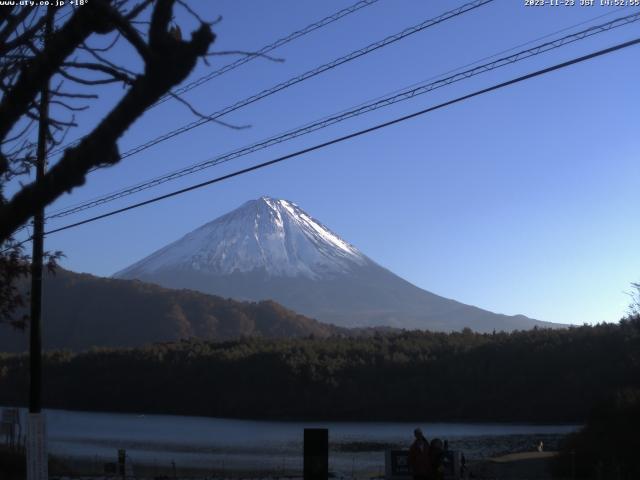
<box><xmin>16</xmin><ymin>0</ymin><xmax>640</xmax><ymax>324</ymax></box>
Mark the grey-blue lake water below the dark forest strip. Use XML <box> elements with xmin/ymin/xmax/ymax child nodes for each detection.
<box><xmin>5</xmin><ymin>410</ymin><xmax>579</xmax><ymax>473</ymax></box>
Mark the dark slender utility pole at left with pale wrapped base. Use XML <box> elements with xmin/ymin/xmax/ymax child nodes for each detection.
<box><xmin>27</xmin><ymin>7</ymin><xmax>54</xmax><ymax>480</ymax></box>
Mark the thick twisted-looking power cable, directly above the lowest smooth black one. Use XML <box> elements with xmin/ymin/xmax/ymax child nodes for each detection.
<box><xmin>47</xmin><ymin>12</ymin><xmax>640</xmax><ymax>219</ymax></box>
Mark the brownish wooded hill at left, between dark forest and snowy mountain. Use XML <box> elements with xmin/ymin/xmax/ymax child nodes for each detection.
<box><xmin>0</xmin><ymin>269</ymin><xmax>342</xmax><ymax>352</ymax></box>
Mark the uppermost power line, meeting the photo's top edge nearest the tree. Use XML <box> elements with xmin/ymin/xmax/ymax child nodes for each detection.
<box><xmin>49</xmin><ymin>0</ymin><xmax>379</xmax><ymax>156</ymax></box>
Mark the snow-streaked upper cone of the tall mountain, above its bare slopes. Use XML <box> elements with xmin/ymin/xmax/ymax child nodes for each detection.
<box><xmin>116</xmin><ymin>196</ymin><xmax>368</xmax><ymax>279</ymax></box>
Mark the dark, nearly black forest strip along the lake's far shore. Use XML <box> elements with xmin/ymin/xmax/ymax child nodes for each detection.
<box><xmin>0</xmin><ymin>317</ymin><xmax>640</xmax><ymax>422</ymax></box>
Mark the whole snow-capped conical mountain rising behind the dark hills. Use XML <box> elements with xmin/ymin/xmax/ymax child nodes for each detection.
<box><xmin>114</xmin><ymin>197</ymin><xmax>559</xmax><ymax>332</ymax></box>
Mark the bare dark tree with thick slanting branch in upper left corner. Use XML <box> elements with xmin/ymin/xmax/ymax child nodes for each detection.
<box><xmin>0</xmin><ymin>0</ymin><xmax>215</xmax><ymax>324</ymax></box>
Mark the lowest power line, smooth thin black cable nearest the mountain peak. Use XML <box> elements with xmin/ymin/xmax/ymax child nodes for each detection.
<box><xmin>38</xmin><ymin>37</ymin><xmax>640</xmax><ymax>239</ymax></box>
